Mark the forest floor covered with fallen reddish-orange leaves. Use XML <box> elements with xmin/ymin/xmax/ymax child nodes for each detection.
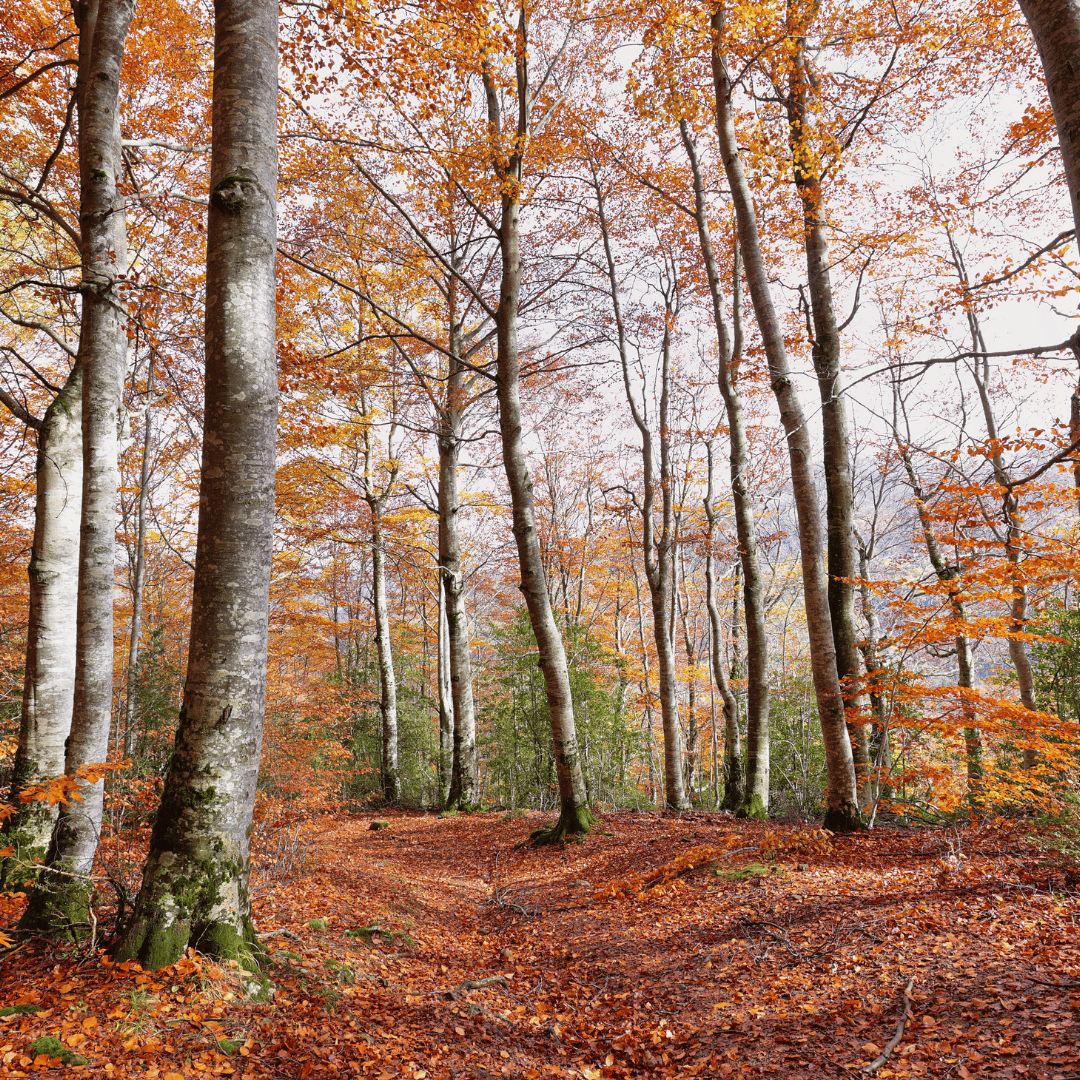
<box><xmin>0</xmin><ymin>812</ymin><xmax>1080</xmax><ymax>1080</ymax></box>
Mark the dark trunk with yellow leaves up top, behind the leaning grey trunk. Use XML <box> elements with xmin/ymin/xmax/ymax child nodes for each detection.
<box><xmin>778</xmin><ymin>31</ymin><xmax>870</xmax><ymax>807</ymax></box>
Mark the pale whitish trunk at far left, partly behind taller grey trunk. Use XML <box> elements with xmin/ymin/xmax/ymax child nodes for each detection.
<box><xmin>0</xmin><ymin>360</ymin><xmax>82</xmax><ymax>886</ymax></box>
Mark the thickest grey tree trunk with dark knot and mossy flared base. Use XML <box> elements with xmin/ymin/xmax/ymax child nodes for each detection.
<box><xmin>117</xmin><ymin>0</ymin><xmax>278</xmax><ymax>970</ymax></box>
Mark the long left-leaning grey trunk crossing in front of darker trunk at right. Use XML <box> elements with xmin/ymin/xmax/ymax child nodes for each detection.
<box><xmin>711</xmin><ymin>6</ymin><xmax>860</xmax><ymax>831</ymax></box>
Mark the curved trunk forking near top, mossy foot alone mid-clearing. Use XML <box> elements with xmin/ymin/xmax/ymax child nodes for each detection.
<box><xmin>483</xmin><ymin>14</ymin><xmax>594</xmax><ymax>842</ymax></box>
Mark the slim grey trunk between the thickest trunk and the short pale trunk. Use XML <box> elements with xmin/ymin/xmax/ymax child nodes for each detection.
<box><xmin>19</xmin><ymin>0</ymin><xmax>135</xmax><ymax>936</ymax></box>
